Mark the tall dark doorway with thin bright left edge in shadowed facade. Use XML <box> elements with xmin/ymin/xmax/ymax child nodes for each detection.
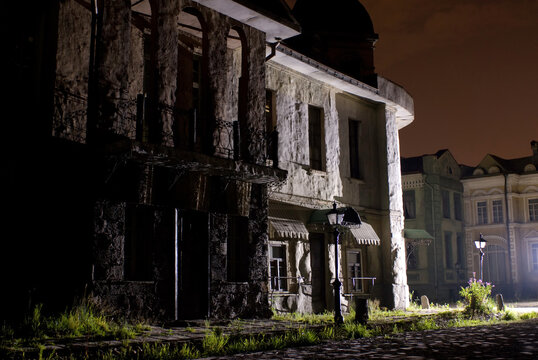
<box><xmin>177</xmin><ymin>211</ymin><xmax>209</xmax><ymax>319</ymax></box>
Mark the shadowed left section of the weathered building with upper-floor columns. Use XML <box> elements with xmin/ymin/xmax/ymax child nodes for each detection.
<box><xmin>2</xmin><ymin>0</ymin><xmax>299</xmax><ymax>320</ymax></box>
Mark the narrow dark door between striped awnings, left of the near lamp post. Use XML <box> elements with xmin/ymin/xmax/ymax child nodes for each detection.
<box><xmin>309</xmin><ymin>233</ymin><xmax>327</xmax><ymax>313</ymax></box>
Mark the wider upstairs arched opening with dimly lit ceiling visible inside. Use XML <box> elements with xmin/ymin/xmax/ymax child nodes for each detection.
<box><xmin>178</xmin><ymin>8</ymin><xmax>207</xmax><ymax>151</ymax></box>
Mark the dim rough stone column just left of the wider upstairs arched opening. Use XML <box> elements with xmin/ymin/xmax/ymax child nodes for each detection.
<box><xmin>150</xmin><ymin>0</ymin><xmax>179</xmax><ymax>146</ymax></box>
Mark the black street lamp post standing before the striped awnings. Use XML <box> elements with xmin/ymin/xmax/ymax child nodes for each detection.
<box><xmin>327</xmin><ymin>201</ymin><xmax>361</xmax><ymax>325</ymax></box>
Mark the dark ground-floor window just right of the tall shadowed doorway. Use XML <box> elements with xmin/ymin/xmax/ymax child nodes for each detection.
<box><xmin>226</xmin><ymin>216</ymin><xmax>249</xmax><ymax>282</ymax></box>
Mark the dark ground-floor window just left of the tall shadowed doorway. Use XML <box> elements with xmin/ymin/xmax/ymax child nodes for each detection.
<box><xmin>124</xmin><ymin>206</ymin><xmax>153</xmax><ymax>281</ymax></box>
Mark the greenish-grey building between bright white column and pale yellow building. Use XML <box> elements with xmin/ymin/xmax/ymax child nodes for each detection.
<box><xmin>402</xmin><ymin>150</ymin><xmax>467</xmax><ymax>302</ymax></box>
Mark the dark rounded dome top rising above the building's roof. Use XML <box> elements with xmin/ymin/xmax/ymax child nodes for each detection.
<box><xmin>293</xmin><ymin>0</ymin><xmax>377</xmax><ymax>39</ymax></box>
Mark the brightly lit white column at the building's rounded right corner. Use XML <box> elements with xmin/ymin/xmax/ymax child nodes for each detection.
<box><xmin>379</xmin><ymin>107</ymin><xmax>409</xmax><ymax>309</ymax></box>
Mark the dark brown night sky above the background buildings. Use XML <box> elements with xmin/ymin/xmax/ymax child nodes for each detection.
<box><xmin>287</xmin><ymin>0</ymin><xmax>538</xmax><ymax>165</ymax></box>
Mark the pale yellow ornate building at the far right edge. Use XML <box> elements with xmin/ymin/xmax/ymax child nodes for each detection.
<box><xmin>461</xmin><ymin>141</ymin><xmax>538</xmax><ymax>299</ymax></box>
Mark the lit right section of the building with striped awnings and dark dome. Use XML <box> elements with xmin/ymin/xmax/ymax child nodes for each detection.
<box><xmin>266</xmin><ymin>0</ymin><xmax>414</xmax><ymax>312</ymax></box>
